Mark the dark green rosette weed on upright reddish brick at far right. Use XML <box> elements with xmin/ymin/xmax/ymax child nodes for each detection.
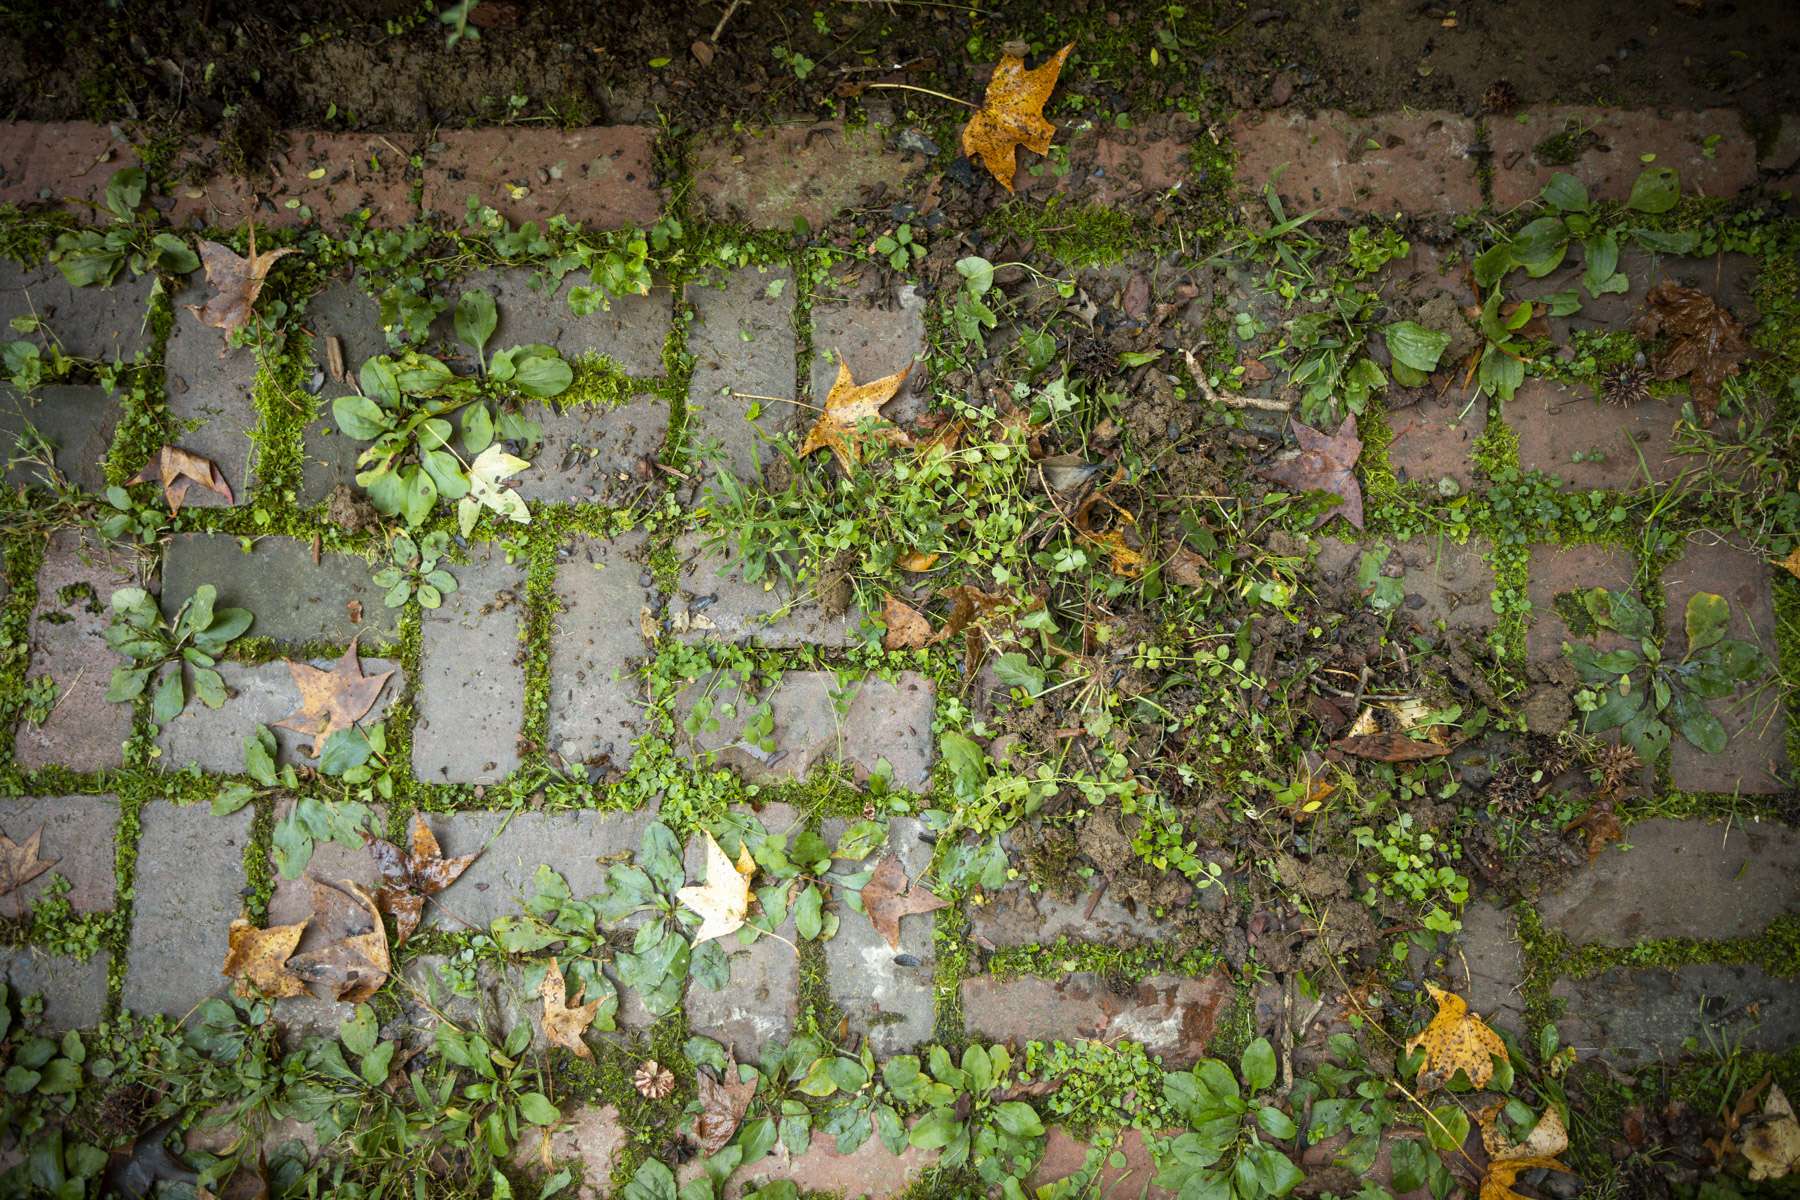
<box><xmin>1562</xmin><ymin>588</ymin><xmax>1769</xmax><ymax>763</ymax></box>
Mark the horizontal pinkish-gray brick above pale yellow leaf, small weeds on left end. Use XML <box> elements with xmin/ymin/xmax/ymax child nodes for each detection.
<box><xmin>679</xmin><ymin>671</ymin><xmax>934</xmax><ymax>792</ymax></box>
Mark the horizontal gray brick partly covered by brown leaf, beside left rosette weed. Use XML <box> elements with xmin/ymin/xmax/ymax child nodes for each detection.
<box><xmin>157</xmin><ymin>658</ymin><xmax>405</xmax><ymax>775</ymax></box>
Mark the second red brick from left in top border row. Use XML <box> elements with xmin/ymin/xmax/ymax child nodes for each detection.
<box><xmin>169</xmin><ymin>131</ymin><xmax>418</xmax><ymax>228</ymax></box>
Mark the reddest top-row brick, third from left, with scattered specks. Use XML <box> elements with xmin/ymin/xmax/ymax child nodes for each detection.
<box><xmin>425</xmin><ymin>126</ymin><xmax>662</xmax><ymax>228</ymax></box>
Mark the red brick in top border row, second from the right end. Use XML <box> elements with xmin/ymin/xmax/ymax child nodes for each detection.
<box><xmin>1231</xmin><ymin>112</ymin><xmax>1481</xmax><ymax>216</ymax></box>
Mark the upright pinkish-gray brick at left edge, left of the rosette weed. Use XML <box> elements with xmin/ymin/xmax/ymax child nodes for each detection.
<box><xmin>13</xmin><ymin>529</ymin><xmax>137</xmax><ymax>772</ymax></box>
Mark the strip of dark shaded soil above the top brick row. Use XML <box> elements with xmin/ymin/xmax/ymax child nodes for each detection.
<box><xmin>0</xmin><ymin>0</ymin><xmax>1800</xmax><ymax>158</ymax></box>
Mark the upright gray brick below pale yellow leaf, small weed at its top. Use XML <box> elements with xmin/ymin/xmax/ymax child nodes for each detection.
<box><xmin>412</xmin><ymin>545</ymin><xmax>526</xmax><ymax>783</ymax></box>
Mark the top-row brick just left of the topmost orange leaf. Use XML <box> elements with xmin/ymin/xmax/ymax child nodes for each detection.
<box><xmin>695</xmin><ymin>121</ymin><xmax>920</xmax><ymax>228</ymax></box>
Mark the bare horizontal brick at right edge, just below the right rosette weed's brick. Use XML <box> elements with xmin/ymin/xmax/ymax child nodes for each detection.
<box><xmin>1537</xmin><ymin>819</ymin><xmax>1800</xmax><ymax>948</ymax></box>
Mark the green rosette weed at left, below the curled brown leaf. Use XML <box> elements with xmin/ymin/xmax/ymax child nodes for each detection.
<box><xmin>106</xmin><ymin>583</ymin><xmax>252</xmax><ymax>725</ymax></box>
